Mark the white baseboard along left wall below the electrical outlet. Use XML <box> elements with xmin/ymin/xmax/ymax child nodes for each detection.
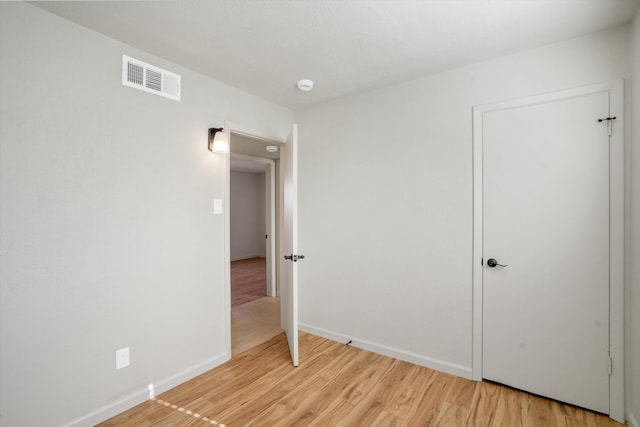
<box><xmin>65</xmin><ymin>353</ymin><xmax>230</xmax><ymax>427</ymax></box>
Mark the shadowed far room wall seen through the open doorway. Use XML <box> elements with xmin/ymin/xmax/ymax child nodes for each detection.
<box><xmin>231</xmin><ymin>172</ymin><xmax>267</xmax><ymax>261</ymax></box>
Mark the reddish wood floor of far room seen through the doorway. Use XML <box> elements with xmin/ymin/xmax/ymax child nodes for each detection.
<box><xmin>231</xmin><ymin>258</ymin><xmax>267</xmax><ymax>307</ymax></box>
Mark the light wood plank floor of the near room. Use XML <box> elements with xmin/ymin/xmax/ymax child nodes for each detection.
<box><xmin>100</xmin><ymin>333</ymin><xmax>621</xmax><ymax>427</ymax></box>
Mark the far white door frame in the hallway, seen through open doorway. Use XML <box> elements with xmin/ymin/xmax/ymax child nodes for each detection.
<box><xmin>230</xmin><ymin>153</ymin><xmax>278</xmax><ymax>297</ymax></box>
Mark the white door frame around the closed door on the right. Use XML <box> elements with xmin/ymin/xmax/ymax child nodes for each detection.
<box><xmin>472</xmin><ymin>80</ymin><xmax>624</xmax><ymax>422</ymax></box>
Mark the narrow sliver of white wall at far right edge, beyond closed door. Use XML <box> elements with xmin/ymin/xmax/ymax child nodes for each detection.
<box><xmin>626</xmin><ymin>10</ymin><xmax>640</xmax><ymax>427</ymax></box>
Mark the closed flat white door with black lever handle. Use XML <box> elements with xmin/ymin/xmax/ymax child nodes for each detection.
<box><xmin>482</xmin><ymin>92</ymin><xmax>610</xmax><ymax>413</ymax></box>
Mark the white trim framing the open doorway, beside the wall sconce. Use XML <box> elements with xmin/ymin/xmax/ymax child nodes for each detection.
<box><xmin>222</xmin><ymin>120</ymin><xmax>284</xmax><ymax>359</ymax></box>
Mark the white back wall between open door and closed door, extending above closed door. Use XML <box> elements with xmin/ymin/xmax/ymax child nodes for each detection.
<box><xmin>296</xmin><ymin>27</ymin><xmax>628</xmax><ymax>376</ymax></box>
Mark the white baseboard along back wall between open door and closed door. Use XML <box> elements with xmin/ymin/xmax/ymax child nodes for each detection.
<box><xmin>300</xmin><ymin>323</ymin><xmax>471</xmax><ymax>379</ymax></box>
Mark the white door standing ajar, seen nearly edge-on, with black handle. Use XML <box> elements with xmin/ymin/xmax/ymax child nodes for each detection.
<box><xmin>280</xmin><ymin>125</ymin><xmax>299</xmax><ymax>366</ymax></box>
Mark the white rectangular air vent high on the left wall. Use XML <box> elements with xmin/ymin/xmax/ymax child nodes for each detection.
<box><xmin>122</xmin><ymin>55</ymin><xmax>180</xmax><ymax>101</ymax></box>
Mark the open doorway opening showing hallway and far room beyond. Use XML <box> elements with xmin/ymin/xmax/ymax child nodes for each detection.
<box><xmin>229</xmin><ymin>133</ymin><xmax>282</xmax><ymax>355</ymax></box>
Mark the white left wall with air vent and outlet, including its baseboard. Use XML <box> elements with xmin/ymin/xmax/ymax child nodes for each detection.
<box><xmin>0</xmin><ymin>2</ymin><xmax>293</xmax><ymax>427</ymax></box>
